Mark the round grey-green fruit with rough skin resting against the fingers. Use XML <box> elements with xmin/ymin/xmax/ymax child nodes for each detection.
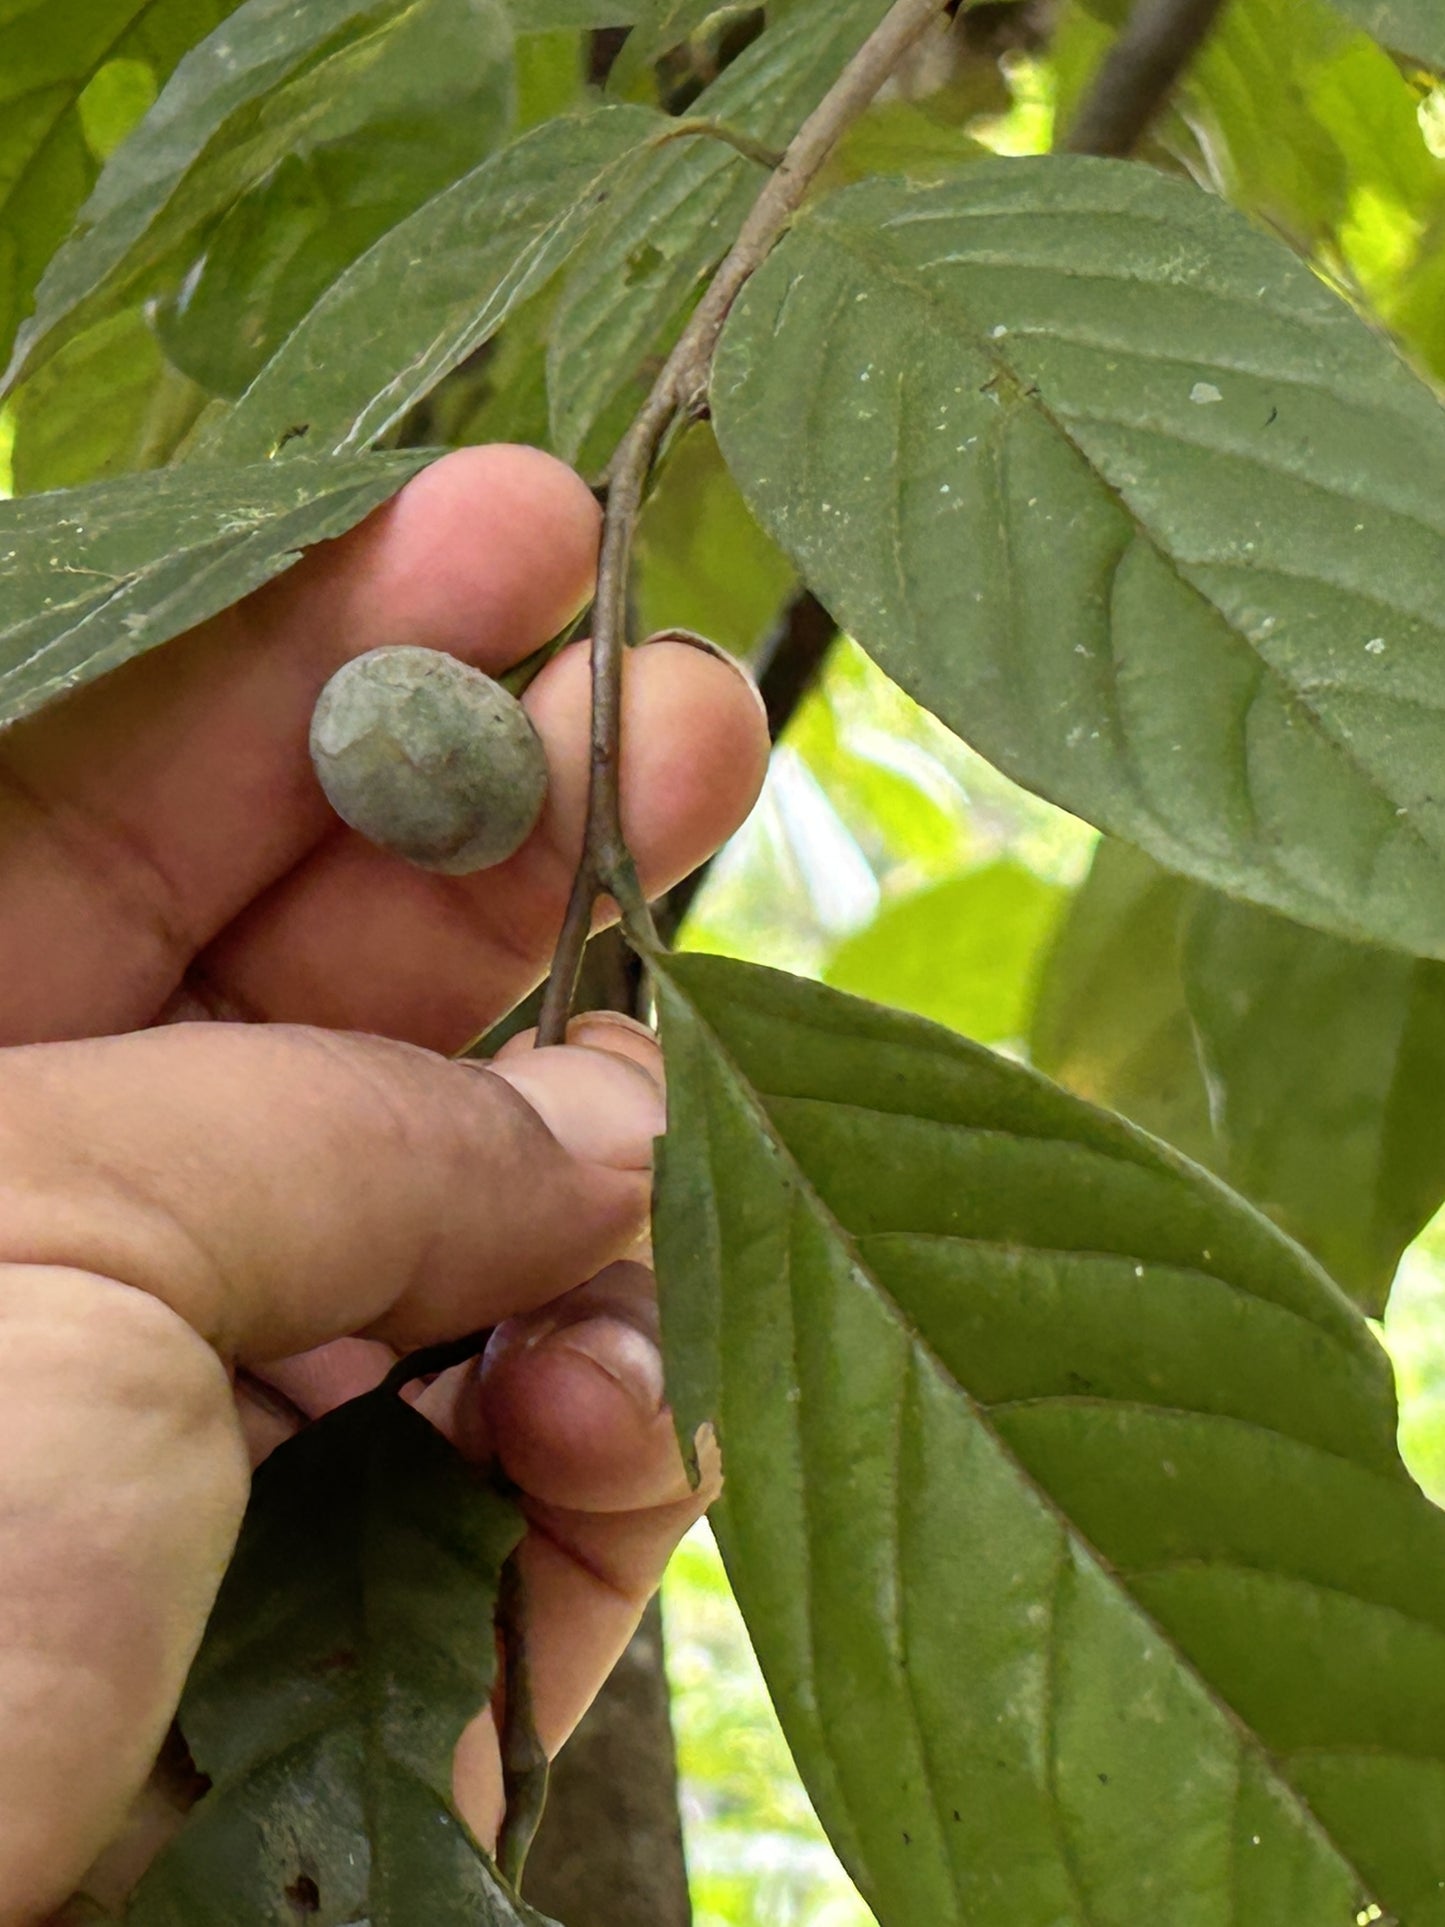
<box><xmin>310</xmin><ymin>646</ymin><xmax>547</xmax><ymax>877</ymax></box>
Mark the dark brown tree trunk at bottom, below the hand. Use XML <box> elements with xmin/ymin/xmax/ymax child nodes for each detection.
<box><xmin>522</xmin><ymin>1599</ymin><xmax>692</xmax><ymax>1927</ymax></box>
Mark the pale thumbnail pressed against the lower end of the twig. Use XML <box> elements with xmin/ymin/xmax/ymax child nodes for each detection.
<box><xmin>486</xmin><ymin>1044</ymin><xmax>667</xmax><ymax>1172</ymax></box>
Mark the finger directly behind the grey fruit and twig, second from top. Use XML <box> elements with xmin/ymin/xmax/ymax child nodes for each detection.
<box><xmin>186</xmin><ymin>642</ymin><xmax>769</xmax><ymax>1050</ymax></box>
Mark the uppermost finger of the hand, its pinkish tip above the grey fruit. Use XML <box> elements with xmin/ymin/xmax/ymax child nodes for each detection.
<box><xmin>0</xmin><ymin>447</ymin><xmax>597</xmax><ymax>1041</ymax></box>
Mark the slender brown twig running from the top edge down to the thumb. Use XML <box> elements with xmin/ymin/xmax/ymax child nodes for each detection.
<box><xmin>538</xmin><ymin>0</ymin><xmax>955</xmax><ymax>1044</ymax></box>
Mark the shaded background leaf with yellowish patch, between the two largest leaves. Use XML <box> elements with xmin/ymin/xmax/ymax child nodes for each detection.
<box><xmin>1029</xmin><ymin>840</ymin><xmax>1220</xmax><ymax>1164</ymax></box>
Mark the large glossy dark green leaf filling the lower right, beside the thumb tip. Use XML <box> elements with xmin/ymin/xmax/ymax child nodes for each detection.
<box><xmin>657</xmin><ymin>958</ymin><xmax>1445</xmax><ymax>1927</ymax></box>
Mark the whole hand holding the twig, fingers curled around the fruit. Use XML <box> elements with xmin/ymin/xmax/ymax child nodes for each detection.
<box><xmin>0</xmin><ymin>447</ymin><xmax>767</xmax><ymax>1927</ymax></box>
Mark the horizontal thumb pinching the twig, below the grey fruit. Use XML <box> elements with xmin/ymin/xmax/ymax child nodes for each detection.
<box><xmin>0</xmin><ymin>1023</ymin><xmax>663</xmax><ymax>1362</ymax></box>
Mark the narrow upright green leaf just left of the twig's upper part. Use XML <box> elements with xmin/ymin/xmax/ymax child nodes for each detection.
<box><xmin>547</xmin><ymin>0</ymin><xmax>901</xmax><ymax>461</ymax></box>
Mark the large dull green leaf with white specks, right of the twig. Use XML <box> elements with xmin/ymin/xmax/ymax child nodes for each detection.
<box><xmin>713</xmin><ymin>156</ymin><xmax>1445</xmax><ymax>956</ymax></box>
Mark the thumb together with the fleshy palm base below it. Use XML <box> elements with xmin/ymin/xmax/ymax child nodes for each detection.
<box><xmin>0</xmin><ymin>1025</ymin><xmax>663</xmax><ymax>1923</ymax></box>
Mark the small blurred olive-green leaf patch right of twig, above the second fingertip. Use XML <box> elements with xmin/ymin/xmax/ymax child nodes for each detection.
<box><xmin>634</xmin><ymin>426</ymin><xmax>798</xmax><ymax>657</ymax></box>
